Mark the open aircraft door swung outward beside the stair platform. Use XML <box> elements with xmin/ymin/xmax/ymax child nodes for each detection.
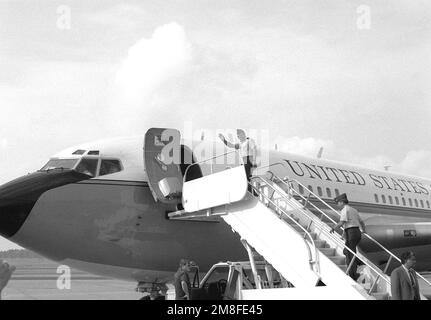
<box><xmin>144</xmin><ymin>128</ymin><xmax>183</xmax><ymax>204</ymax></box>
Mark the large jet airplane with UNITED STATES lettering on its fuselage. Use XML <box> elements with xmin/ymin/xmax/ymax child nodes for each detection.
<box><xmin>0</xmin><ymin>128</ymin><xmax>431</xmax><ymax>296</ymax></box>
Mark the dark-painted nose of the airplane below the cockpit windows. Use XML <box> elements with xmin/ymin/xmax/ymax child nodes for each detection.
<box><xmin>0</xmin><ymin>169</ymin><xmax>89</xmax><ymax>238</ymax></box>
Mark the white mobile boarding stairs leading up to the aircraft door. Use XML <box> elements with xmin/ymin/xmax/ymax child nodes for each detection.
<box><xmin>169</xmin><ymin>156</ymin><xmax>430</xmax><ymax>300</ymax></box>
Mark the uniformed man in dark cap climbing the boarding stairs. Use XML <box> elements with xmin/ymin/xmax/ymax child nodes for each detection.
<box><xmin>331</xmin><ymin>193</ymin><xmax>365</xmax><ymax>281</ymax></box>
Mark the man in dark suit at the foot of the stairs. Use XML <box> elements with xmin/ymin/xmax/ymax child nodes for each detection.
<box><xmin>391</xmin><ymin>251</ymin><xmax>421</xmax><ymax>300</ymax></box>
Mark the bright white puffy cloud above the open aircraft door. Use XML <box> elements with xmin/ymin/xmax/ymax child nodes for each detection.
<box><xmin>117</xmin><ymin>22</ymin><xmax>192</xmax><ymax>104</ymax></box>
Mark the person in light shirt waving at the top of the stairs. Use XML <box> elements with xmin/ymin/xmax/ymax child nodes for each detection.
<box><xmin>219</xmin><ymin>129</ymin><xmax>256</xmax><ymax>191</ymax></box>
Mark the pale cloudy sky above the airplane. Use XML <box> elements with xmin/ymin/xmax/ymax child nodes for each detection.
<box><xmin>0</xmin><ymin>0</ymin><xmax>431</xmax><ymax>250</ymax></box>
